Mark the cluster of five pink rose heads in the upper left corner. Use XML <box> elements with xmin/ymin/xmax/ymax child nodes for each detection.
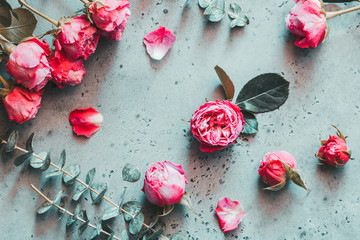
<box><xmin>3</xmin><ymin>0</ymin><xmax>130</xmax><ymax>123</ymax></box>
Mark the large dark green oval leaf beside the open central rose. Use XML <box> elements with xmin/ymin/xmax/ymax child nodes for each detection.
<box><xmin>236</xmin><ymin>73</ymin><xmax>290</xmax><ymax>113</ymax></box>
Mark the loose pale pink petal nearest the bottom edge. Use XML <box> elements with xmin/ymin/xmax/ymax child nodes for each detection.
<box><xmin>215</xmin><ymin>197</ymin><xmax>245</xmax><ymax>233</ymax></box>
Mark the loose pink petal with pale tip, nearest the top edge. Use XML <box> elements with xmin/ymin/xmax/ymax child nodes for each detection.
<box><xmin>144</xmin><ymin>27</ymin><xmax>176</xmax><ymax>60</ymax></box>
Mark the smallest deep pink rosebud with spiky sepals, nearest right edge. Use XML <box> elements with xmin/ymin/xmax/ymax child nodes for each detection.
<box><xmin>316</xmin><ymin>126</ymin><xmax>351</xmax><ymax>167</ymax></box>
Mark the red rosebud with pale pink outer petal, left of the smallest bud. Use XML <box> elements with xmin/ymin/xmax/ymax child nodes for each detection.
<box><xmin>258</xmin><ymin>151</ymin><xmax>296</xmax><ymax>186</ymax></box>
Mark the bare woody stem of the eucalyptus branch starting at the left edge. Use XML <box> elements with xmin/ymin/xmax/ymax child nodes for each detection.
<box><xmin>0</xmin><ymin>139</ymin><xmax>168</xmax><ymax>240</ymax></box>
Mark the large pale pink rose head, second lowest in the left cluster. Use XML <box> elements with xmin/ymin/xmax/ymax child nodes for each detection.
<box><xmin>7</xmin><ymin>38</ymin><xmax>51</xmax><ymax>91</ymax></box>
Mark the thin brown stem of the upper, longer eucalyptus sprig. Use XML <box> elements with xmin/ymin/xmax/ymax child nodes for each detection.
<box><xmin>1</xmin><ymin>140</ymin><xmax>168</xmax><ymax>240</ymax></box>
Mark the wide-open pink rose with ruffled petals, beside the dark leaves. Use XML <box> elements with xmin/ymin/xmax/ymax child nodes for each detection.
<box><xmin>191</xmin><ymin>100</ymin><xmax>245</xmax><ymax>152</ymax></box>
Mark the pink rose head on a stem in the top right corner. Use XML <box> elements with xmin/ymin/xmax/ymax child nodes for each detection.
<box><xmin>285</xmin><ymin>0</ymin><xmax>329</xmax><ymax>48</ymax></box>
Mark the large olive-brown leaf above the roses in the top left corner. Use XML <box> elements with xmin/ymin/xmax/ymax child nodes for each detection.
<box><xmin>0</xmin><ymin>8</ymin><xmax>37</xmax><ymax>43</ymax></box>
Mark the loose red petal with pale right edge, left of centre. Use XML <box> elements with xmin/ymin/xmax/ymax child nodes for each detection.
<box><xmin>69</xmin><ymin>108</ymin><xmax>104</xmax><ymax>137</ymax></box>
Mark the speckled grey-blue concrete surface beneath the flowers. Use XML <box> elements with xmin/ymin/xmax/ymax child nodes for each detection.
<box><xmin>0</xmin><ymin>0</ymin><xmax>360</xmax><ymax>240</ymax></box>
